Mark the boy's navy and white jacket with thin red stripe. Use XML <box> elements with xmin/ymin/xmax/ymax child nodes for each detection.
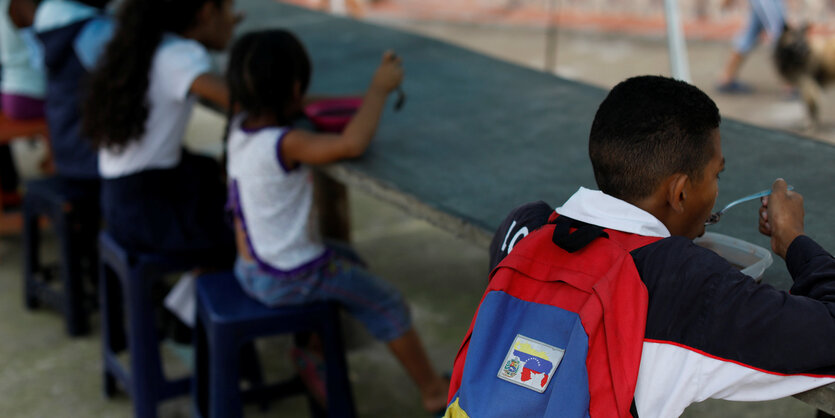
<box><xmin>490</xmin><ymin>188</ymin><xmax>835</xmax><ymax>418</ymax></box>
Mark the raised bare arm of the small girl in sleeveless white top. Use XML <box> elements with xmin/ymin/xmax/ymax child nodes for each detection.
<box><xmin>281</xmin><ymin>51</ymin><xmax>403</xmax><ymax>166</ymax></box>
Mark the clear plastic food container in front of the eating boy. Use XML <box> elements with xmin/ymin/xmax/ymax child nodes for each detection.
<box><xmin>693</xmin><ymin>232</ymin><xmax>773</xmax><ymax>282</ymax></box>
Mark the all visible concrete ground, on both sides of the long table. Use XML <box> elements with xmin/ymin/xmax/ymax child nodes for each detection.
<box><xmin>0</xmin><ymin>11</ymin><xmax>835</xmax><ymax>418</ymax></box>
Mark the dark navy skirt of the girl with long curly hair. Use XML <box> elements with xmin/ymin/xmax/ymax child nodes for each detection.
<box><xmin>101</xmin><ymin>151</ymin><xmax>236</xmax><ymax>268</ymax></box>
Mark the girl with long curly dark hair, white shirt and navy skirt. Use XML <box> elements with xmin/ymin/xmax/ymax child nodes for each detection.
<box><xmin>82</xmin><ymin>0</ymin><xmax>240</xmax><ymax>266</ymax></box>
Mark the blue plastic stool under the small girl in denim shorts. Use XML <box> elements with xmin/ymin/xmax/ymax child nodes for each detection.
<box><xmin>193</xmin><ymin>272</ymin><xmax>356</xmax><ymax>418</ymax></box>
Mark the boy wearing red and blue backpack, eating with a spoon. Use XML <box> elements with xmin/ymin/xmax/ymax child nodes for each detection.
<box><xmin>446</xmin><ymin>76</ymin><xmax>835</xmax><ymax>418</ymax></box>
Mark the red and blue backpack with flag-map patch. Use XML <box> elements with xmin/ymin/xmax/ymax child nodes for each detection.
<box><xmin>446</xmin><ymin>212</ymin><xmax>660</xmax><ymax>418</ymax></box>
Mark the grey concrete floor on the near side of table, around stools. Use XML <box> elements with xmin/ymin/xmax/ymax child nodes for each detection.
<box><xmin>0</xmin><ymin>183</ymin><xmax>487</xmax><ymax>417</ymax></box>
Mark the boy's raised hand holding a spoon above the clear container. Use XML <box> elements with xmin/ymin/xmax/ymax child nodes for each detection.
<box><xmin>759</xmin><ymin>179</ymin><xmax>804</xmax><ymax>258</ymax></box>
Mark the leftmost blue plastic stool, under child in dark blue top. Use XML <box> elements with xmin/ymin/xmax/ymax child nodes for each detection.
<box><xmin>23</xmin><ymin>177</ymin><xmax>100</xmax><ymax>336</ymax></box>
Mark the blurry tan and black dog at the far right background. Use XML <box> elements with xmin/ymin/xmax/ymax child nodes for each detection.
<box><xmin>774</xmin><ymin>24</ymin><xmax>835</xmax><ymax>129</ymax></box>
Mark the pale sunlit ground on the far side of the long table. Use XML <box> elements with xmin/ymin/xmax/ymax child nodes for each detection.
<box><xmin>378</xmin><ymin>21</ymin><xmax>835</xmax><ymax>144</ymax></box>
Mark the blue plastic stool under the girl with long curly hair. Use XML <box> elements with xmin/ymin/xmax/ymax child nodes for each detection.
<box><xmin>99</xmin><ymin>232</ymin><xmax>196</xmax><ymax>417</ymax></box>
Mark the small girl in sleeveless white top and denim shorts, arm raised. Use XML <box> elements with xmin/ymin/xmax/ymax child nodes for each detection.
<box><xmin>227</xmin><ymin>30</ymin><xmax>449</xmax><ymax>412</ymax></box>
